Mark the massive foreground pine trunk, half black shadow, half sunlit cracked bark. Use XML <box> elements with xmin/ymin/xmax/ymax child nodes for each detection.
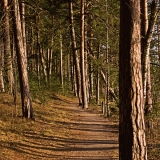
<box><xmin>119</xmin><ymin>0</ymin><xmax>147</xmax><ymax>160</ymax></box>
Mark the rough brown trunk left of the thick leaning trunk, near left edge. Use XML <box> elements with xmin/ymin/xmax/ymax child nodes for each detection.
<box><xmin>3</xmin><ymin>0</ymin><xmax>14</xmax><ymax>94</ymax></box>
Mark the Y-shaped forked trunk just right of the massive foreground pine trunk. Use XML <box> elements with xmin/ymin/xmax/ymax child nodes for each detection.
<box><xmin>141</xmin><ymin>0</ymin><xmax>158</xmax><ymax>114</ymax></box>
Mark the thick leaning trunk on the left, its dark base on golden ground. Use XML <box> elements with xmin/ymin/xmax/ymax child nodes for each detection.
<box><xmin>13</xmin><ymin>0</ymin><xmax>33</xmax><ymax>119</ymax></box>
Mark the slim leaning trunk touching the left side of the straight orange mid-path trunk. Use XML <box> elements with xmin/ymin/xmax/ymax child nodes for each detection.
<box><xmin>69</xmin><ymin>0</ymin><xmax>82</xmax><ymax>105</ymax></box>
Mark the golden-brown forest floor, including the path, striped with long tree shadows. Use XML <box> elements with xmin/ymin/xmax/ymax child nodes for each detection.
<box><xmin>0</xmin><ymin>93</ymin><xmax>160</xmax><ymax>160</ymax></box>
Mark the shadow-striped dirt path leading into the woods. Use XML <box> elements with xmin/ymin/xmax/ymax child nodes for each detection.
<box><xmin>51</xmin><ymin>100</ymin><xmax>118</xmax><ymax>160</ymax></box>
